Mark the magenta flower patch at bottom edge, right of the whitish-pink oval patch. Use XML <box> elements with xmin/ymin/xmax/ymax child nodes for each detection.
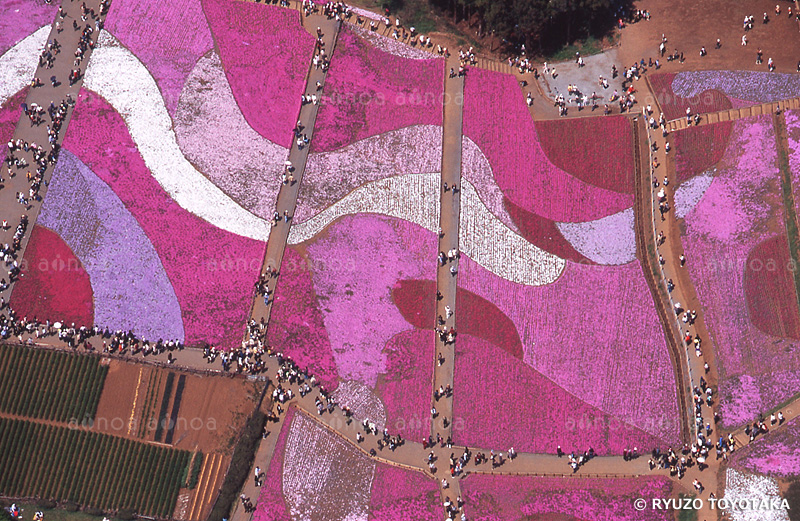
<box><xmin>369</xmin><ymin>463</ymin><xmax>442</xmax><ymax>521</ymax></box>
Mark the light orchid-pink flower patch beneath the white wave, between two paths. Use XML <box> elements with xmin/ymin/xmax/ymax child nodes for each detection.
<box><xmin>305</xmin><ymin>215</ymin><xmax>436</xmax><ymax>387</ymax></box>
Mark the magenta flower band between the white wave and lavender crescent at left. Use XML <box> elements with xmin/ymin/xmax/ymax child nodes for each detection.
<box><xmin>64</xmin><ymin>92</ymin><xmax>265</xmax><ymax>348</ymax></box>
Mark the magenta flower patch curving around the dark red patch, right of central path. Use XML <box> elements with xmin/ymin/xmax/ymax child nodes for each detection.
<box><xmin>464</xmin><ymin>69</ymin><xmax>633</xmax><ymax>222</ymax></box>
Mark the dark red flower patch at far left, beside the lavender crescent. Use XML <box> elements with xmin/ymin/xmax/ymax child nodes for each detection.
<box><xmin>9</xmin><ymin>226</ymin><xmax>94</xmax><ymax>325</ymax></box>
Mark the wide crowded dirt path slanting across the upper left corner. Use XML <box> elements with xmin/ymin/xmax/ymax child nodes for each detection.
<box><xmin>0</xmin><ymin>0</ymin><xmax>110</xmax><ymax>303</ymax></box>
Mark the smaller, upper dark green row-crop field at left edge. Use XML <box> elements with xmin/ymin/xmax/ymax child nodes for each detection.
<box><xmin>0</xmin><ymin>345</ymin><xmax>108</xmax><ymax>422</ymax></box>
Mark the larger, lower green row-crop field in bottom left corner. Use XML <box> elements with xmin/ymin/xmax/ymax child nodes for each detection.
<box><xmin>0</xmin><ymin>419</ymin><xmax>191</xmax><ymax>517</ymax></box>
